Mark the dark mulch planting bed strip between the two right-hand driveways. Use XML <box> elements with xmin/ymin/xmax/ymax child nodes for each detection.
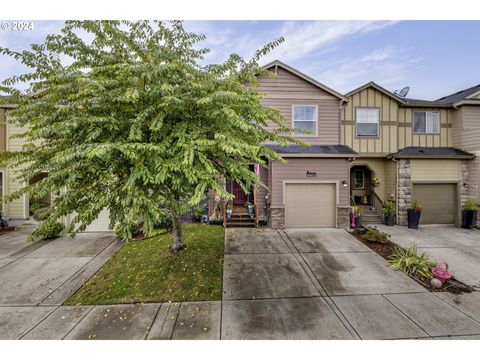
<box><xmin>351</xmin><ymin>227</ymin><xmax>473</xmax><ymax>294</ymax></box>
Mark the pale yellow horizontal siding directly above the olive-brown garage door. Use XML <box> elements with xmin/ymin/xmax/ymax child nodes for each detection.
<box><xmin>410</xmin><ymin>159</ymin><xmax>461</xmax><ymax>182</ymax></box>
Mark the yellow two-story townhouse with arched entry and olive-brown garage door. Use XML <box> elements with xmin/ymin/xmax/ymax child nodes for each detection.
<box><xmin>341</xmin><ymin>82</ymin><xmax>480</xmax><ymax>225</ymax></box>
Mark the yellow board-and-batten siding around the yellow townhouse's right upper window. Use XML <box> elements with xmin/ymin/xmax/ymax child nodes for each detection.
<box><xmin>398</xmin><ymin>107</ymin><xmax>455</xmax><ymax>149</ymax></box>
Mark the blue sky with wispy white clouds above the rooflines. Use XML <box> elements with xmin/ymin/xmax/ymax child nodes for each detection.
<box><xmin>0</xmin><ymin>21</ymin><xmax>480</xmax><ymax>100</ymax></box>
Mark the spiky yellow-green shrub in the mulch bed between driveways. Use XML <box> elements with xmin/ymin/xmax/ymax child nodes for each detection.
<box><xmin>389</xmin><ymin>246</ymin><xmax>435</xmax><ymax>279</ymax></box>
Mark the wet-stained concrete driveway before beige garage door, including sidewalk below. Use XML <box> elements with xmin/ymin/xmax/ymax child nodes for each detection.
<box><xmin>221</xmin><ymin>229</ymin><xmax>480</xmax><ymax>339</ymax></box>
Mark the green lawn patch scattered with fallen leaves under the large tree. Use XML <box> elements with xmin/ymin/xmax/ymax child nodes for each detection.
<box><xmin>65</xmin><ymin>224</ymin><xmax>224</xmax><ymax>305</ymax></box>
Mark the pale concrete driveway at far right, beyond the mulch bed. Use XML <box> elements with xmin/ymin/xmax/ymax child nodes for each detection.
<box><xmin>377</xmin><ymin>225</ymin><xmax>480</xmax><ymax>290</ymax></box>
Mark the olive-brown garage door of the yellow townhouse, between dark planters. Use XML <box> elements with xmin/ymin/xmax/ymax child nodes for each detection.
<box><xmin>413</xmin><ymin>184</ymin><xmax>457</xmax><ymax>224</ymax></box>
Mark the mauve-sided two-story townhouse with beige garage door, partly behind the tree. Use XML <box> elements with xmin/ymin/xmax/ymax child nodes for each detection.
<box><xmin>209</xmin><ymin>61</ymin><xmax>356</xmax><ymax>228</ymax></box>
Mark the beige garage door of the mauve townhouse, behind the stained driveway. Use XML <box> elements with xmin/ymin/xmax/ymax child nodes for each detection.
<box><xmin>285</xmin><ymin>183</ymin><xmax>336</xmax><ymax>227</ymax></box>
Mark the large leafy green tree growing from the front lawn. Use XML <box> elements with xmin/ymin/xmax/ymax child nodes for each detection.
<box><xmin>0</xmin><ymin>21</ymin><xmax>293</xmax><ymax>250</ymax></box>
